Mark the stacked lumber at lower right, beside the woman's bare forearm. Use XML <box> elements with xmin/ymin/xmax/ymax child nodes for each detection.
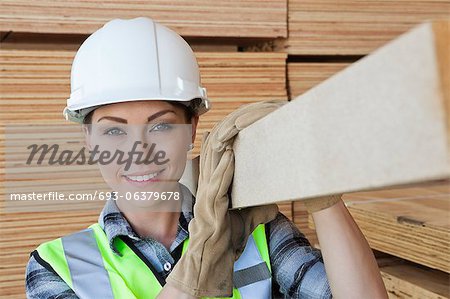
<box><xmin>310</xmin><ymin>180</ymin><xmax>450</xmax><ymax>299</ymax></box>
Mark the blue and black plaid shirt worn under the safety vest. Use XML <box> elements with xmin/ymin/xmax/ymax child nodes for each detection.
<box><xmin>26</xmin><ymin>184</ymin><xmax>331</xmax><ymax>299</ymax></box>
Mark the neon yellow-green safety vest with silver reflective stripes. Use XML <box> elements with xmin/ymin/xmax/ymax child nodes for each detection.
<box><xmin>32</xmin><ymin>223</ymin><xmax>272</xmax><ymax>299</ymax></box>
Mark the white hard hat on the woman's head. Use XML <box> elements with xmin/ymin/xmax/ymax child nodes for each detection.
<box><xmin>63</xmin><ymin>17</ymin><xmax>210</xmax><ymax>123</ymax></box>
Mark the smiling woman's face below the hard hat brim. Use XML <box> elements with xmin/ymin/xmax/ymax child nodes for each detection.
<box><xmin>85</xmin><ymin>101</ymin><xmax>198</xmax><ymax>208</ymax></box>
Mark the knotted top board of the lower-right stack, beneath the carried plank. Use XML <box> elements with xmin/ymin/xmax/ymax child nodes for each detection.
<box><xmin>343</xmin><ymin>181</ymin><xmax>450</xmax><ymax>273</ymax></box>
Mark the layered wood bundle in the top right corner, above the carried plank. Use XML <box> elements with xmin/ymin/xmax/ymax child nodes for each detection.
<box><xmin>278</xmin><ymin>0</ymin><xmax>450</xmax><ymax>55</ymax></box>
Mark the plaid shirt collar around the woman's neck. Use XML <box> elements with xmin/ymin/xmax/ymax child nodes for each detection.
<box><xmin>98</xmin><ymin>183</ymin><xmax>195</xmax><ymax>254</ymax></box>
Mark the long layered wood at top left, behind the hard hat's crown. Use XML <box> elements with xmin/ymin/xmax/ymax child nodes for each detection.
<box><xmin>0</xmin><ymin>0</ymin><xmax>287</xmax><ymax>38</ymax></box>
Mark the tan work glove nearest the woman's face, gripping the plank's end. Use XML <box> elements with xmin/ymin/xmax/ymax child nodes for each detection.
<box><xmin>167</xmin><ymin>101</ymin><xmax>286</xmax><ymax>297</ymax></box>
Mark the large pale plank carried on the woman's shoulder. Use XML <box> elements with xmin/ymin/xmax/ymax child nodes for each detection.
<box><xmin>232</xmin><ymin>22</ymin><xmax>450</xmax><ymax>208</ymax></box>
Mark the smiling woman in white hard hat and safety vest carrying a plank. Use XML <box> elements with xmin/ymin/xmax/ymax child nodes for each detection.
<box><xmin>26</xmin><ymin>18</ymin><xmax>387</xmax><ymax>298</ymax></box>
